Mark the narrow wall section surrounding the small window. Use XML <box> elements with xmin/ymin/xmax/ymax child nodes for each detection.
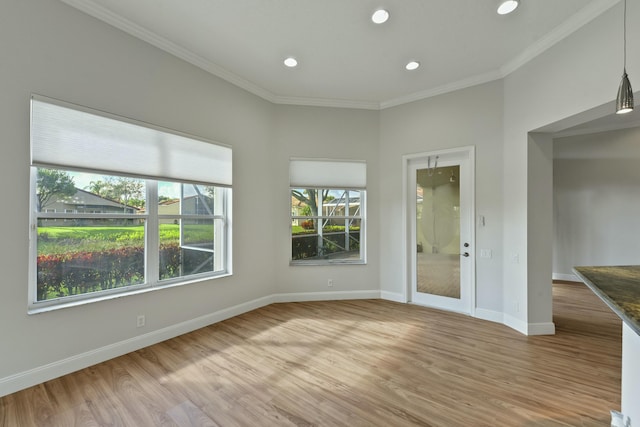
<box><xmin>271</xmin><ymin>105</ymin><xmax>380</xmax><ymax>300</ymax></box>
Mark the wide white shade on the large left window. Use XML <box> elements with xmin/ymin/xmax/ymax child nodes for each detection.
<box><xmin>31</xmin><ymin>96</ymin><xmax>232</xmax><ymax>186</ymax></box>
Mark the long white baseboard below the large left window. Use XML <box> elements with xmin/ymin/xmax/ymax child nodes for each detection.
<box><xmin>0</xmin><ymin>296</ymin><xmax>274</xmax><ymax>396</ymax></box>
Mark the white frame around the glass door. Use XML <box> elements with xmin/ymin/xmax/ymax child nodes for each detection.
<box><xmin>402</xmin><ymin>145</ymin><xmax>476</xmax><ymax>316</ymax></box>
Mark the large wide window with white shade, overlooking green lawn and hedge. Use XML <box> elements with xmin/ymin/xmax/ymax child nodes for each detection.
<box><xmin>29</xmin><ymin>97</ymin><xmax>231</xmax><ymax>311</ymax></box>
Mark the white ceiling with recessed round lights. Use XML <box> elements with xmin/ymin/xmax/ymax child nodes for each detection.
<box><xmin>62</xmin><ymin>0</ymin><xmax>619</xmax><ymax>109</ymax></box>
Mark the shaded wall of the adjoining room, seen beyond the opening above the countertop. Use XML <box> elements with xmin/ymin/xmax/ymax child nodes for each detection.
<box><xmin>553</xmin><ymin>128</ymin><xmax>640</xmax><ymax>280</ymax></box>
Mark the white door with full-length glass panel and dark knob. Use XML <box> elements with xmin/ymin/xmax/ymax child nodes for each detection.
<box><xmin>408</xmin><ymin>153</ymin><xmax>473</xmax><ymax>313</ymax></box>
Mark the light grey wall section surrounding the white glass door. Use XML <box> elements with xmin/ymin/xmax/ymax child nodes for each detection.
<box><xmin>379</xmin><ymin>81</ymin><xmax>503</xmax><ymax>317</ymax></box>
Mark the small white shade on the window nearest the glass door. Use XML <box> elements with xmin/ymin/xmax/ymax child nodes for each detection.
<box><xmin>289</xmin><ymin>159</ymin><xmax>367</xmax><ymax>189</ymax></box>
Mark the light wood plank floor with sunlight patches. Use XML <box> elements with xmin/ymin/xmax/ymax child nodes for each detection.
<box><xmin>0</xmin><ymin>284</ymin><xmax>621</xmax><ymax>427</ymax></box>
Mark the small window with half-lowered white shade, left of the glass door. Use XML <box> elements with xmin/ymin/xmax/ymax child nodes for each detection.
<box><xmin>289</xmin><ymin>159</ymin><xmax>367</xmax><ymax>265</ymax></box>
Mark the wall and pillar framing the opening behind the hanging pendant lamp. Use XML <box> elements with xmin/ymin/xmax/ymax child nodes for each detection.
<box><xmin>503</xmin><ymin>0</ymin><xmax>640</xmax><ymax>333</ymax></box>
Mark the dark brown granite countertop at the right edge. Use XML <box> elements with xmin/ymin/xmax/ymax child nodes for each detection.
<box><xmin>573</xmin><ymin>265</ymin><xmax>640</xmax><ymax>335</ymax></box>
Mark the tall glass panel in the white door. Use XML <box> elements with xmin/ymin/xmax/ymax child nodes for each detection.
<box><xmin>416</xmin><ymin>165</ymin><xmax>460</xmax><ymax>299</ymax></box>
